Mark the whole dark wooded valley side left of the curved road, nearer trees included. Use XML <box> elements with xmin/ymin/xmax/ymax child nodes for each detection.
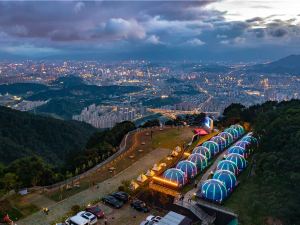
<box><xmin>0</xmin><ymin>107</ymin><xmax>135</xmax><ymax>191</ymax></box>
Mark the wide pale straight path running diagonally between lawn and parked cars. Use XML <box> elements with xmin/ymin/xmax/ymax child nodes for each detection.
<box><xmin>17</xmin><ymin>148</ymin><xmax>170</xmax><ymax>225</ymax></box>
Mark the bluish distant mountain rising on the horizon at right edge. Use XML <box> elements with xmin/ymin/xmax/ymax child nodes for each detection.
<box><xmin>247</xmin><ymin>55</ymin><xmax>300</xmax><ymax>75</ymax></box>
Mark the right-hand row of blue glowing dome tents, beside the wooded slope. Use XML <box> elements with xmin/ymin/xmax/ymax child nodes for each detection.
<box><xmin>196</xmin><ymin>133</ymin><xmax>258</xmax><ymax>203</ymax></box>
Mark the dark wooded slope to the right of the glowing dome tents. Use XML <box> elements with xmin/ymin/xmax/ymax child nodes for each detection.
<box><xmin>221</xmin><ymin>100</ymin><xmax>300</xmax><ymax>225</ymax></box>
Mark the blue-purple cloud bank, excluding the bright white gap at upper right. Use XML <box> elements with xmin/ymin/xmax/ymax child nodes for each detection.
<box><xmin>0</xmin><ymin>0</ymin><xmax>300</xmax><ymax>60</ymax></box>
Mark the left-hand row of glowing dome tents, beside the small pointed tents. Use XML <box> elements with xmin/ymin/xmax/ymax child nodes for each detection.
<box><xmin>163</xmin><ymin>124</ymin><xmax>245</xmax><ymax>187</ymax></box>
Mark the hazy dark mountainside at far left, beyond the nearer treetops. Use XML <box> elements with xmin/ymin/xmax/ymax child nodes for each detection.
<box><xmin>0</xmin><ymin>107</ymin><xmax>97</xmax><ymax>166</ymax></box>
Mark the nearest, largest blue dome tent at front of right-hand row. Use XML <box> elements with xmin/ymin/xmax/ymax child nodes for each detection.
<box><xmin>197</xmin><ymin>179</ymin><xmax>227</xmax><ymax>203</ymax></box>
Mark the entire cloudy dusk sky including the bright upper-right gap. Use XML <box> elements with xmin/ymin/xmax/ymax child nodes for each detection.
<box><xmin>0</xmin><ymin>0</ymin><xmax>300</xmax><ymax>61</ymax></box>
